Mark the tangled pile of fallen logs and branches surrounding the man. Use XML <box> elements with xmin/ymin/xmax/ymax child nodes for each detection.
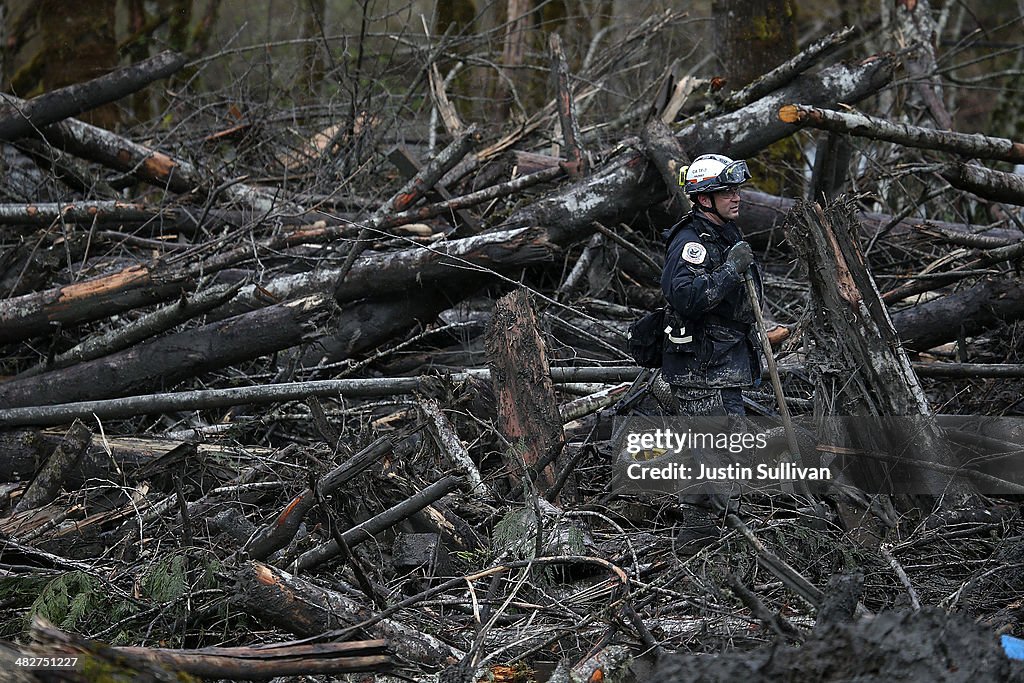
<box><xmin>0</xmin><ymin>14</ymin><xmax>1024</xmax><ymax>681</ymax></box>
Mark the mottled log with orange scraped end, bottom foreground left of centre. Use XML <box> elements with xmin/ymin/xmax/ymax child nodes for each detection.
<box><xmin>236</xmin><ymin>562</ymin><xmax>463</xmax><ymax>669</ymax></box>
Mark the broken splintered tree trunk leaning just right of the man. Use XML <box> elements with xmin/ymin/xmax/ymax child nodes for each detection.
<box><xmin>785</xmin><ymin>198</ymin><xmax>973</xmax><ymax>505</ymax></box>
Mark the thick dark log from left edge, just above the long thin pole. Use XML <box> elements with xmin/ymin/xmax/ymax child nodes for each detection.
<box><xmin>0</xmin><ymin>296</ymin><xmax>334</xmax><ymax>407</ymax></box>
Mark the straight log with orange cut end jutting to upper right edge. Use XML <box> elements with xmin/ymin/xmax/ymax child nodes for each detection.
<box><xmin>778</xmin><ymin>103</ymin><xmax>1024</xmax><ymax>164</ymax></box>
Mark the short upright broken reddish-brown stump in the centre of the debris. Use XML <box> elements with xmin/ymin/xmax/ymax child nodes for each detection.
<box><xmin>484</xmin><ymin>289</ymin><xmax>565</xmax><ymax>496</ymax></box>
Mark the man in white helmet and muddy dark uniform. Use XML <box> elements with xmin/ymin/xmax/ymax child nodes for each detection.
<box><xmin>662</xmin><ymin>155</ymin><xmax>762</xmax><ymax>416</ymax></box>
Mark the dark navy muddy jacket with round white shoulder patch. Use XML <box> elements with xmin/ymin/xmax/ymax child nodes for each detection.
<box><xmin>662</xmin><ymin>212</ymin><xmax>762</xmax><ymax>387</ymax></box>
